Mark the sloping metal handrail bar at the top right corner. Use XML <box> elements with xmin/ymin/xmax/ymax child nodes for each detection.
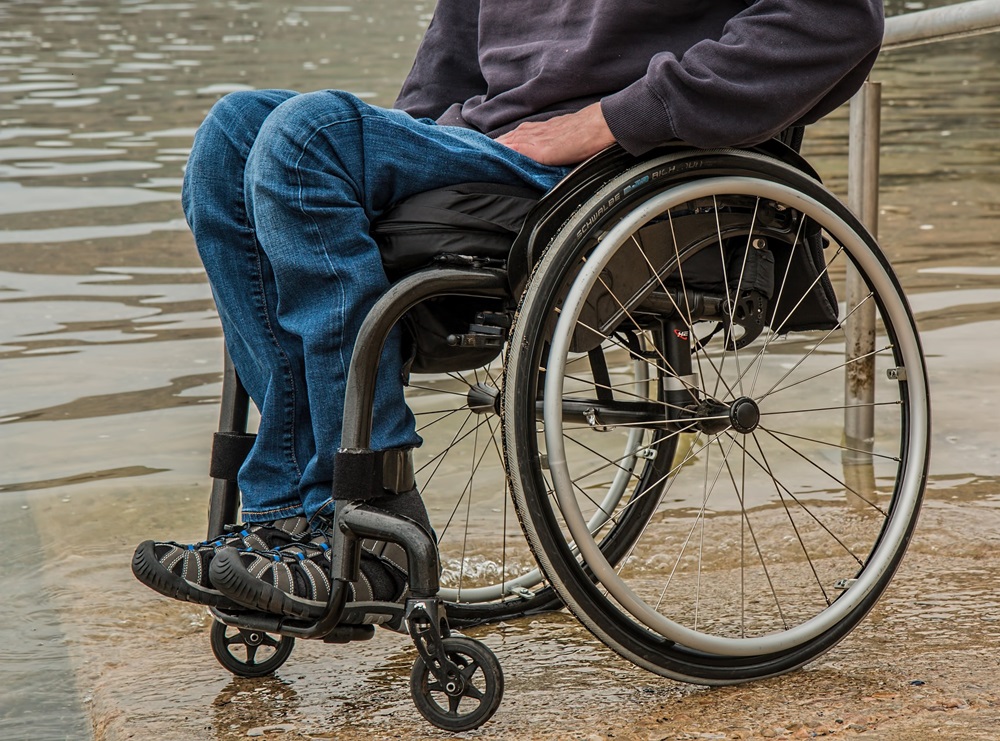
<box><xmin>882</xmin><ymin>0</ymin><xmax>1000</xmax><ymax>51</ymax></box>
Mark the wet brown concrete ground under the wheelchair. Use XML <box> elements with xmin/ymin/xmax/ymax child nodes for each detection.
<box><xmin>13</xmin><ymin>472</ymin><xmax>1000</xmax><ymax>741</ymax></box>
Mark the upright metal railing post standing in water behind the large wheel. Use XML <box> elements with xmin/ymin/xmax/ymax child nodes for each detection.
<box><xmin>844</xmin><ymin>81</ymin><xmax>882</xmax><ymax>463</ymax></box>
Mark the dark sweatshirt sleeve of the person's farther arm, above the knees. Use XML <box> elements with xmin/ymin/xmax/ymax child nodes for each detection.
<box><xmin>393</xmin><ymin>0</ymin><xmax>486</xmax><ymax>119</ymax></box>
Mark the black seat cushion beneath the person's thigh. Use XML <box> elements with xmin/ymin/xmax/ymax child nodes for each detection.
<box><xmin>372</xmin><ymin>183</ymin><xmax>542</xmax><ymax>280</ymax></box>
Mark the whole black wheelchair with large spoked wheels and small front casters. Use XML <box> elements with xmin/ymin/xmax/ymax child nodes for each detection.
<box><xmin>201</xmin><ymin>139</ymin><xmax>930</xmax><ymax>731</ymax></box>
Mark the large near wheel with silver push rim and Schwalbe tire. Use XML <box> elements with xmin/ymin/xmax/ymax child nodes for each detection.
<box><xmin>503</xmin><ymin>150</ymin><xmax>930</xmax><ymax>684</ymax></box>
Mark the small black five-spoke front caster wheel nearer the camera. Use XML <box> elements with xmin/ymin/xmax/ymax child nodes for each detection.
<box><xmin>410</xmin><ymin>636</ymin><xmax>503</xmax><ymax>733</ymax></box>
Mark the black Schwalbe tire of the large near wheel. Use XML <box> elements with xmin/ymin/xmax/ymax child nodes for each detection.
<box><xmin>504</xmin><ymin>151</ymin><xmax>929</xmax><ymax>685</ymax></box>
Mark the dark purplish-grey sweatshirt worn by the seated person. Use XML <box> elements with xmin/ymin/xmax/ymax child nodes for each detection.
<box><xmin>396</xmin><ymin>0</ymin><xmax>883</xmax><ymax>154</ymax></box>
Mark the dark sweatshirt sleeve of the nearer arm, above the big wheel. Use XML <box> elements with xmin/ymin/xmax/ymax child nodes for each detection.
<box><xmin>601</xmin><ymin>0</ymin><xmax>884</xmax><ymax>154</ymax></box>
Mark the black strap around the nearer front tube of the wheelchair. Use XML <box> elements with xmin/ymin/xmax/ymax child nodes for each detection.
<box><xmin>333</xmin><ymin>448</ymin><xmax>415</xmax><ymax>501</ymax></box>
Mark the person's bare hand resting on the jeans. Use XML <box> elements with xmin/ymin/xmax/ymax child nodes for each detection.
<box><xmin>497</xmin><ymin>103</ymin><xmax>615</xmax><ymax>165</ymax></box>
